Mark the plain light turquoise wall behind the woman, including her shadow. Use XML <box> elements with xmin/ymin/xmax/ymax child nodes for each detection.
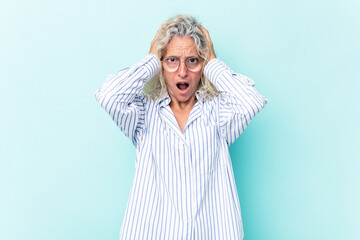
<box><xmin>0</xmin><ymin>0</ymin><xmax>360</xmax><ymax>240</ymax></box>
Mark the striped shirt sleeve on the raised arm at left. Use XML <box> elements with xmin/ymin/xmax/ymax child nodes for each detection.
<box><xmin>95</xmin><ymin>54</ymin><xmax>160</xmax><ymax>145</ymax></box>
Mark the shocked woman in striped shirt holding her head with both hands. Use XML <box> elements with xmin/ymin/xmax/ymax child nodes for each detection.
<box><xmin>96</xmin><ymin>16</ymin><xmax>267</xmax><ymax>239</ymax></box>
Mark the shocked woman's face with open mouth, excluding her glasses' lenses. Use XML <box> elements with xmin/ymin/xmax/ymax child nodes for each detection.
<box><xmin>163</xmin><ymin>36</ymin><xmax>203</xmax><ymax>104</ymax></box>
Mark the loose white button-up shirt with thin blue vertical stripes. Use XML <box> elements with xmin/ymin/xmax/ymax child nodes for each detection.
<box><xmin>95</xmin><ymin>54</ymin><xmax>267</xmax><ymax>239</ymax></box>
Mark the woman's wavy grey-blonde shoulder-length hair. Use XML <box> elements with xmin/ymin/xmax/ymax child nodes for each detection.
<box><xmin>143</xmin><ymin>15</ymin><xmax>219</xmax><ymax>100</ymax></box>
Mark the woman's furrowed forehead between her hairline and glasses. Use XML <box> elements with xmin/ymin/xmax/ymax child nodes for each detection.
<box><xmin>164</xmin><ymin>36</ymin><xmax>199</xmax><ymax>57</ymax></box>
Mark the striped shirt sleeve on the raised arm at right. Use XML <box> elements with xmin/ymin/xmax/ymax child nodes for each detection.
<box><xmin>204</xmin><ymin>59</ymin><xmax>267</xmax><ymax>146</ymax></box>
